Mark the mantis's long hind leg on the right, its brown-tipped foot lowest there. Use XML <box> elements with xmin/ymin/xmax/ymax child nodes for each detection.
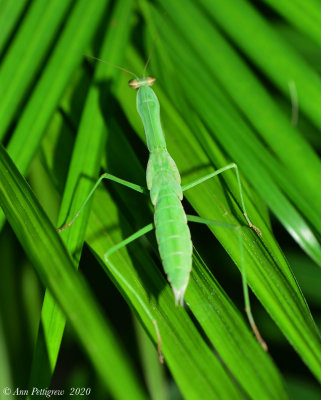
<box><xmin>187</xmin><ymin>215</ymin><xmax>268</xmax><ymax>351</ymax></box>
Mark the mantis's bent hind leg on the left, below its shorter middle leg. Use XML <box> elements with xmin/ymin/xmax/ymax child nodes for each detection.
<box><xmin>104</xmin><ymin>224</ymin><xmax>164</xmax><ymax>363</ymax></box>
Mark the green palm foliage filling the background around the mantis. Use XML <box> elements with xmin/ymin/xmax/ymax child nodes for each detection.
<box><xmin>0</xmin><ymin>0</ymin><xmax>321</xmax><ymax>400</ymax></box>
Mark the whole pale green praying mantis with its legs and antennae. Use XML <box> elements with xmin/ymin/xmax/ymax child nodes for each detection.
<box><xmin>58</xmin><ymin>57</ymin><xmax>267</xmax><ymax>359</ymax></box>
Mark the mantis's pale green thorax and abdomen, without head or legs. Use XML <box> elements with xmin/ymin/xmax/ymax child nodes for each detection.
<box><xmin>137</xmin><ymin>86</ymin><xmax>193</xmax><ymax>304</ymax></box>
